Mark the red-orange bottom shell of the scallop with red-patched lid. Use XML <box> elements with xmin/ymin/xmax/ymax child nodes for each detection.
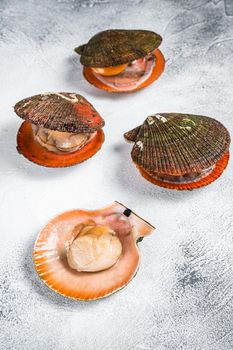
<box><xmin>17</xmin><ymin>121</ymin><xmax>104</xmax><ymax>168</ymax></box>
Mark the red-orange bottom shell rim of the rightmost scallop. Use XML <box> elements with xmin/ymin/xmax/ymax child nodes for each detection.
<box><xmin>137</xmin><ymin>152</ymin><xmax>230</xmax><ymax>190</ymax></box>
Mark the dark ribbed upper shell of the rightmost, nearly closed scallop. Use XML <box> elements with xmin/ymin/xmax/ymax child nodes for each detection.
<box><xmin>125</xmin><ymin>113</ymin><xmax>230</xmax><ymax>175</ymax></box>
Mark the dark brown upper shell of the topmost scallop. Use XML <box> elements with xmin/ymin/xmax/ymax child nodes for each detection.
<box><xmin>75</xmin><ymin>29</ymin><xmax>162</xmax><ymax>67</ymax></box>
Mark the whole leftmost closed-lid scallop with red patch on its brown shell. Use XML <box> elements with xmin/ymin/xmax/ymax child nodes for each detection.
<box><xmin>15</xmin><ymin>92</ymin><xmax>104</xmax><ymax>167</ymax></box>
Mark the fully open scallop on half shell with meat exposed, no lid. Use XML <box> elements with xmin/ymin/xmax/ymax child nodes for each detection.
<box><xmin>33</xmin><ymin>202</ymin><xmax>154</xmax><ymax>300</ymax></box>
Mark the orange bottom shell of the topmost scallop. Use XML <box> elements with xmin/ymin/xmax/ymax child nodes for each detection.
<box><xmin>83</xmin><ymin>49</ymin><xmax>165</xmax><ymax>92</ymax></box>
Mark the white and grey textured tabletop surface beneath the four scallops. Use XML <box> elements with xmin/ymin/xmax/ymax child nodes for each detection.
<box><xmin>0</xmin><ymin>0</ymin><xmax>233</xmax><ymax>350</ymax></box>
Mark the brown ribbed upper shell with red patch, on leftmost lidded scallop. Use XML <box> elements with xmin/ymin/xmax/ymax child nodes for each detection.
<box><xmin>14</xmin><ymin>92</ymin><xmax>104</xmax><ymax>133</ymax></box>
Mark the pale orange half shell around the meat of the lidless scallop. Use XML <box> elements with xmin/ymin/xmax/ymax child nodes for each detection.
<box><xmin>33</xmin><ymin>202</ymin><xmax>154</xmax><ymax>300</ymax></box>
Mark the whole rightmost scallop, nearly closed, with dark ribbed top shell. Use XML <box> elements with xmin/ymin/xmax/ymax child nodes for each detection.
<box><xmin>124</xmin><ymin>113</ymin><xmax>230</xmax><ymax>189</ymax></box>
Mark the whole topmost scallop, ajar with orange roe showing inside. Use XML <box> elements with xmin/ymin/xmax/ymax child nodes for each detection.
<box><xmin>75</xmin><ymin>29</ymin><xmax>165</xmax><ymax>92</ymax></box>
